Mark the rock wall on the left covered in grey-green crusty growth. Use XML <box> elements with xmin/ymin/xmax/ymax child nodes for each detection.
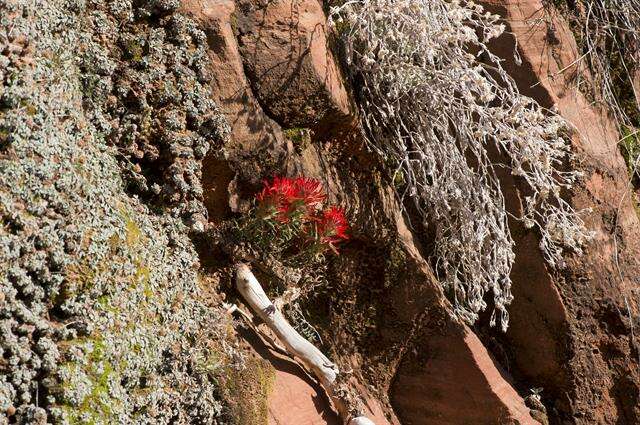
<box><xmin>0</xmin><ymin>0</ymin><xmax>237</xmax><ymax>424</ymax></box>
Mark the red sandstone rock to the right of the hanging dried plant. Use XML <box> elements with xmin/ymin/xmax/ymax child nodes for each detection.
<box><xmin>483</xmin><ymin>0</ymin><xmax>640</xmax><ymax>424</ymax></box>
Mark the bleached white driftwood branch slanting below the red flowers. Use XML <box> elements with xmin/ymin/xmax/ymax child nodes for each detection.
<box><xmin>236</xmin><ymin>263</ymin><xmax>374</xmax><ymax>425</ymax></box>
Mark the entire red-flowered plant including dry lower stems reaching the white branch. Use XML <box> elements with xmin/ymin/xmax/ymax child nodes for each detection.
<box><xmin>222</xmin><ymin>177</ymin><xmax>349</xmax><ymax>341</ymax></box>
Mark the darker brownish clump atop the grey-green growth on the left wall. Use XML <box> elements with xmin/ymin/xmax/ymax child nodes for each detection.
<box><xmin>81</xmin><ymin>1</ymin><xmax>228</xmax><ymax>230</ymax></box>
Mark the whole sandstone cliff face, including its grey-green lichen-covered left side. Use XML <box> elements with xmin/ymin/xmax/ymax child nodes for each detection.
<box><xmin>0</xmin><ymin>0</ymin><xmax>640</xmax><ymax>424</ymax></box>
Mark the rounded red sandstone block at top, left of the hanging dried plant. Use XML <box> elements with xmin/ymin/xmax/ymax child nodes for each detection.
<box><xmin>238</xmin><ymin>0</ymin><xmax>351</xmax><ymax>131</ymax></box>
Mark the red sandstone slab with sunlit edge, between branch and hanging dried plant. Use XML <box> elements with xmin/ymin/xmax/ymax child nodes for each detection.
<box><xmin>294</xmin><ymin>146</ymin><xmax>537</xmax><ymax>425</ymax></box>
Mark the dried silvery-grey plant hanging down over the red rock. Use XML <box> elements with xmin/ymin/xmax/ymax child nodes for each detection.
<box><xmin>331</xmin><ymin>0</ymin><xmax>590</xmax><ymax>330</ymax></box>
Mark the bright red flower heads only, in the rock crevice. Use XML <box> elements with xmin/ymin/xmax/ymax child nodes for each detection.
<box><xmin>256</xmin><ymin>177</ymin><xmax>349</xmax><ymax>251</ymax></box>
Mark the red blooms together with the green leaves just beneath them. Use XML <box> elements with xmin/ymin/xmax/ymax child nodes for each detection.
<box><xmin>252</xmin><ymin>177</ymin><xmax>349</xmax><ymax>256</ymax></box>
